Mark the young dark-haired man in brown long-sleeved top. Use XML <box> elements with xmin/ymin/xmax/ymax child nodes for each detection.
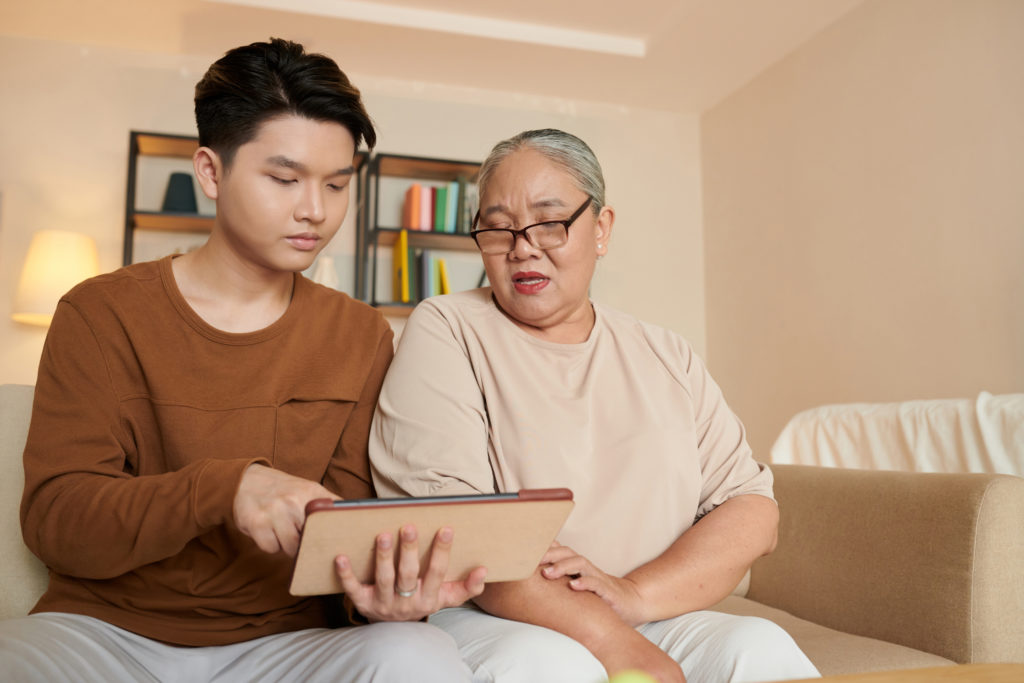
<box><xmin>0</xmin><ymin>40</ymin><xmax>483</xmax><ymax>681</ymax></box>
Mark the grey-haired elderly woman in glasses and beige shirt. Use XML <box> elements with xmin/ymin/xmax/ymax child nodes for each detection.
<box><xmin>370</xmin><ymin>130</ymin><xmax>817</xmax><ymax>683</ymax></box>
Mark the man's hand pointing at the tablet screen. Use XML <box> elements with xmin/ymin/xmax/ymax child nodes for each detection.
<box><xmin>233</xmin><ymin>464</ymin><xmax>338</xmax><ymax>557</ymax></box>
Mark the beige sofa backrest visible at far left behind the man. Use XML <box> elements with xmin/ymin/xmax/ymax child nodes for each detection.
<box><xmin>0</xmin><ymin>384</ymin><xmax>47</xmax><ymax>618</ymax></box>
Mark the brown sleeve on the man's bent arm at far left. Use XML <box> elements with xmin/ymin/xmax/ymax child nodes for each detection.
<box><xmin>20</xmin><ymin>300</ymin><xmax>267</xmax><ymax>579</ymax></box>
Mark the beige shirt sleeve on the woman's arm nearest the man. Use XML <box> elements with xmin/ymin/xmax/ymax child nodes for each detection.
<box><xmin>370</xmin><ymin>297</ymin><xmax>495</xmax><ymax>498</ymax></box>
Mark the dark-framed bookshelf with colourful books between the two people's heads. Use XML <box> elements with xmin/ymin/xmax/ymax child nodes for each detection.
<box><xmin>355</xmin><ymin>154</ymin><xmax>483</xmax><ymax>316</ymax></box>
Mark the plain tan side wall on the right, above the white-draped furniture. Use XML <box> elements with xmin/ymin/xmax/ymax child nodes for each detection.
<box><xmin>701</xmin><ymin>0</ymin><xmax>1024</xmax><ymax>456</ymax></box>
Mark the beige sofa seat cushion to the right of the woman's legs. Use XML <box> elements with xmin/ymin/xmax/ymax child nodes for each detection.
<box><xmin>712</xmin><ymin>595</ymin><xmax>955</xmax><ymax>676</ymax></box>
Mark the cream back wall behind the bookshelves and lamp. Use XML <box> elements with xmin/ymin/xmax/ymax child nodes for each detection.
<box><xmin>0</xmin><ymin>34</ymin><xmax>705</xmax><ymax>383</ymax></box>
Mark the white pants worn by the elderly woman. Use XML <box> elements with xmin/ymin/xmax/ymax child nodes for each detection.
<box><xmin>430</xmin><ymin>607</ymin><xmax>819</xmax><ymax>683</ymax></box>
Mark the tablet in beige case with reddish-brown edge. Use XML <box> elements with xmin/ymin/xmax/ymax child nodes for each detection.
<box><xmin>290</xmin><ymin>488</ymin><xmax>572</xmax><ymax>595</ymax></box>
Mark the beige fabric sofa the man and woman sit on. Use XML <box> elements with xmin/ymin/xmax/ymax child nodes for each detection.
<box><xmin>6</xmin><ymin>385</ymin><xmax>1024</xmax><ymax>674</ymax></box>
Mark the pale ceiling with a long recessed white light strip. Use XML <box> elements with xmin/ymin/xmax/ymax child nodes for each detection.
<box><xmin>0</xmin><ymin>0</ymin><xmax>863</xmax><ymax>113</ymax></box>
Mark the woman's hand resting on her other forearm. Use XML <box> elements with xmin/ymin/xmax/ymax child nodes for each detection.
<box><xmin>541</xmin><ymin>542</ymin><xmax>647</xmax><ymax>627</ymax></box>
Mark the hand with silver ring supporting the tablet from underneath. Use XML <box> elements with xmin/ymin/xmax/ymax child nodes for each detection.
<box><xmin>335</xmin><ymin>524</ymin><xmax>487</xmax><ymax>622</ymax></box>
